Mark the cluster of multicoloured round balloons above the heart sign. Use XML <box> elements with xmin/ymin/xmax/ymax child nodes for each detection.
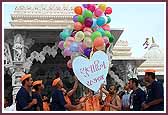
<box><xmin>58</xmin><ymin>4</ymin><xmax>114</xmax><ymax>68</ymax></box>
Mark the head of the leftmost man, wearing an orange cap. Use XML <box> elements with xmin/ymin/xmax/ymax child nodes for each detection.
<box><xmin>20</xmin><ymin>74</ymin><xmax>33</xmax><ymax>87</ymax></box>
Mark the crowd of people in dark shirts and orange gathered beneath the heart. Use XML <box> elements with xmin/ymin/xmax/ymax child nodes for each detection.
<box><xmin>4</xmin><ymin>69</ymin><xmax>164</xmax><ymax>111</ymax></box>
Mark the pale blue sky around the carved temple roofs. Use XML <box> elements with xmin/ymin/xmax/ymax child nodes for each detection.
<box><xmin>3</xmin><ymin>3</ymin><xmax>166</xmax><ymax>57</ymax></box>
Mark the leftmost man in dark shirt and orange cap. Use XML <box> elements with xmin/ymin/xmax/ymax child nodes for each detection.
<box><xmin>16</xmin><ymin>74</ymin><xmax>37</xmax><ymax>111</ymax></box>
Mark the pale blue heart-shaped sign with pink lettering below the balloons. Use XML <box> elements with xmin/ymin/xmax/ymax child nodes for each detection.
<box><xmin>72</xmin><ymin>51</ymin><xmax>109</xmax><ymax>92</ymax></box>
